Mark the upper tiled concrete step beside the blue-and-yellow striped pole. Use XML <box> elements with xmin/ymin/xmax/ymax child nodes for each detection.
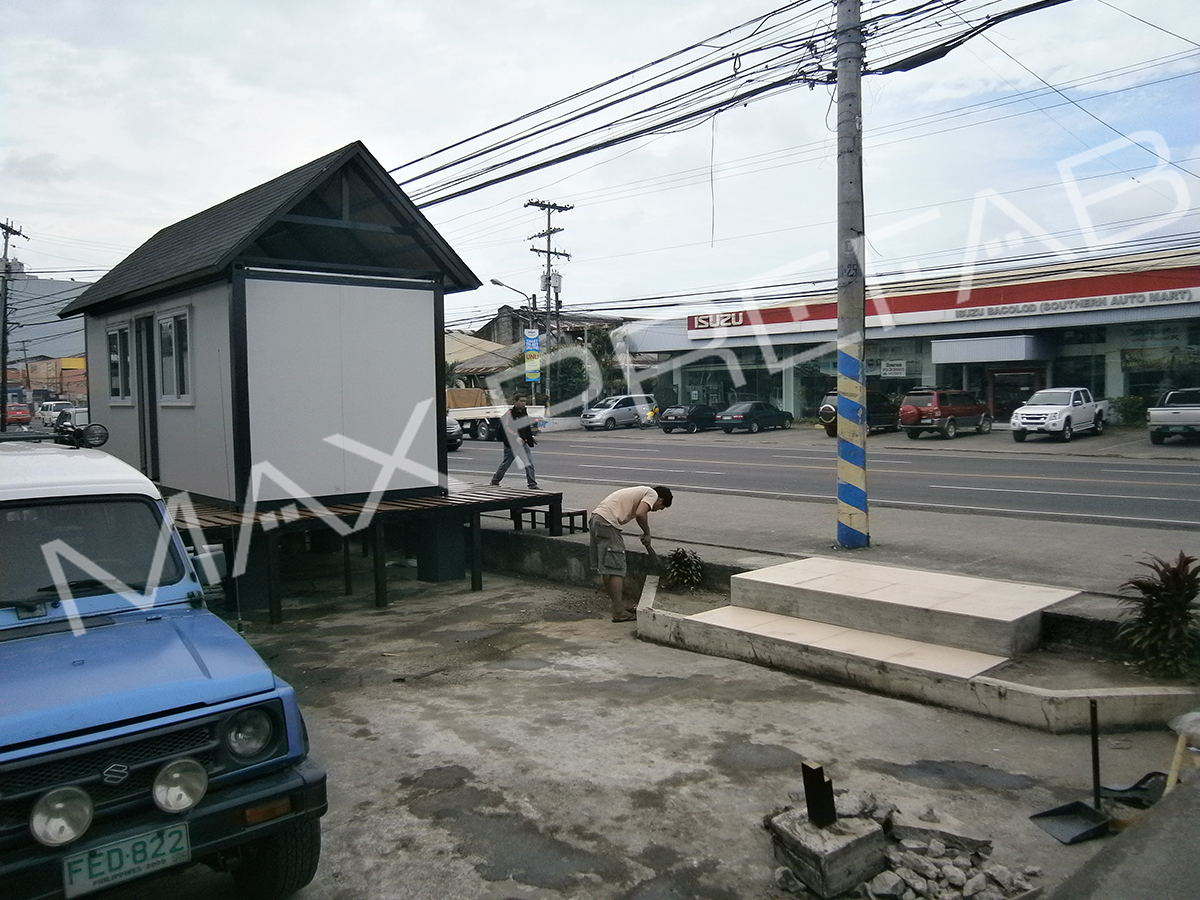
<box><xmin>730</xmin><ymin>557</ymin><xmax>1079</xmax><ymax>658</ymax></box>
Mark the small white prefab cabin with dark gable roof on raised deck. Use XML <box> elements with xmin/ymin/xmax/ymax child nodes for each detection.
<box><xmin>61</xmin><ymin>142</ymin><xmax>480</xmax><ymax>506</ymax></box>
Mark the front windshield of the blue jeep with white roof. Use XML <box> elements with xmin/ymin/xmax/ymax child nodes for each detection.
<box><xmin>0</xmin><ymin>497</ymin><xmax>185</xmax><ymax>607</ymax></box>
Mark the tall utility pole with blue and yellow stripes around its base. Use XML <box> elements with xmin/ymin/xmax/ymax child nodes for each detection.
<box><xmin>838</xmin><ymin>0</ymin><xmax>871</xmax><ymax>548</ymax></box>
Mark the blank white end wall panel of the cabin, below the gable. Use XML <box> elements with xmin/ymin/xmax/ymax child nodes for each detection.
<box><xmin>246</xmin><ymin>278</ymin><xmax>438</xmax><ymax>500</ymax></box>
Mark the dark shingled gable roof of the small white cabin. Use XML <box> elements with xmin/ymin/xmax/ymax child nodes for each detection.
<box><xmin>59</xmin><ymin>140</ymin><xmax>481</xmax><ymax>317</ymax></box>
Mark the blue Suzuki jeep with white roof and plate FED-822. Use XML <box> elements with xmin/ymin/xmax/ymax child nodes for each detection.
<box><xmin>0</xmin><ymin>420</ymin><xmax>326</xmax><ymax>900</ymax></box>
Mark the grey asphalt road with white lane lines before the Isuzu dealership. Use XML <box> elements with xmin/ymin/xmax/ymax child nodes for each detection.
<box><xmin>450</xmin><ymin>426</ymin><xmax>1200</xmax><ymax>530</ymax></box>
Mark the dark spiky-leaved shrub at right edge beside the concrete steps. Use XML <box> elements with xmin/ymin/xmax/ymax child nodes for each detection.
<box><xmin>1117</xmin><ymin>551</ymin><xmax>1200</xmax><ymax>677</ymax></box>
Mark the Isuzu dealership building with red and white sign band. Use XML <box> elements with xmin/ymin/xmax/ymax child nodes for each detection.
<box><xmin>623</xmin><ymin>244</ymin><xmax>1200</xmax><ymax>419</ymax></box>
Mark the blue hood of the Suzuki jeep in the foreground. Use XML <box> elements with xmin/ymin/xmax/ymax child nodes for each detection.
<box><xmin>0</xmin><ymin>608</ymin><xmax>276</xmax><ymax>750</ymax></box>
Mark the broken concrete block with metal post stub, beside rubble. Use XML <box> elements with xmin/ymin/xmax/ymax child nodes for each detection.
<box><xmin>767</xmin><ymin>810</ymin><xmax>887</xmax><ymax>898</ymax></box>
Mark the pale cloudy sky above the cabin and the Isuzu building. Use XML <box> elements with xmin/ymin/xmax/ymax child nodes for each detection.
<box><xmin>0</xmin><ymin>0</ymin><xmax>1200</xmax><ymax>355</ymax></box>
